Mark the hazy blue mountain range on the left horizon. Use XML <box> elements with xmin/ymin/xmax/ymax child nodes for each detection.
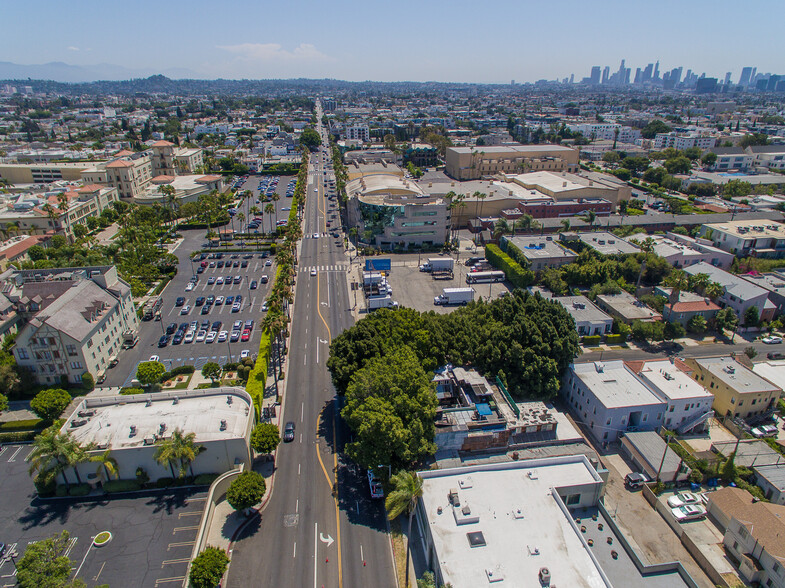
<box><xmin>0</xmin><ymin>61</ymin><xmax>198</xmax><ymax>84</ymax></box>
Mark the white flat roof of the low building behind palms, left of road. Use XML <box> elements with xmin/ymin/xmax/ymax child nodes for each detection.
<box><xmin>62</xmin><ymin>388</ymin><xmax>253</xmax><ymax>449</ymax></box>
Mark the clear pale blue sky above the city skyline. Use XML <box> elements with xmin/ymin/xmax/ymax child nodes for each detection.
<box><xmin>0</xmin><ymin>0</ymin><xmax>785</xmax><ymax>83</ymax></box>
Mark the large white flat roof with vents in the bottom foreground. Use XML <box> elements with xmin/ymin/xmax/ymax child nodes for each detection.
<box><xmin>419</xmin><ymin>456</ymin><xmax>611</xmax><ymax>588</ymax></box>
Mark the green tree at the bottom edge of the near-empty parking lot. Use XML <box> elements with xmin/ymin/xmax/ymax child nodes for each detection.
<box><xmin>16</xmin><ymin>531</ymin><xmax>85</xmax><ymax>588</ymax></box>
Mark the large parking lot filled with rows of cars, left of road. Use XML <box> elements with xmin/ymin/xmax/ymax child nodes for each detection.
<box><xmin>104</xmin><ymin>230</ymin><xmax>276</xmax><ymax>386</ymax></box>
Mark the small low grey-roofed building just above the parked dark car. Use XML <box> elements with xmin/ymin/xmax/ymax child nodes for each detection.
<box><xmin>621</xmin><ymin>431</ymin><xmax>691</xmax><ymax>483</ymax></box>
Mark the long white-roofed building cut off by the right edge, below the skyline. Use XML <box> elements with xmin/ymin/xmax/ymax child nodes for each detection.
<box><xmin>700</xmin><ymin>220</ymin><xmax>785</xmax><ymax>258</ymax></box>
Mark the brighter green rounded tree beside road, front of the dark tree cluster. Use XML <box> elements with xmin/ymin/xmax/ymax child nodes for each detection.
<box><xmin>341</xmin><ymin>346</ymin><xmax>437</xmax><ymax>468</ymax></box>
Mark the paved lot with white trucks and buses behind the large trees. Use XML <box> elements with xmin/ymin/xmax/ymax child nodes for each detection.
<box><xmin>352</xmin><ymin>252</ymin><xmax>512</xmax><ymax>314</ymax></box>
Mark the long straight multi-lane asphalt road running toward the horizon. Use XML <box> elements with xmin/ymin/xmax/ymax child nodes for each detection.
<box><xmin>227</xmin><ymin>108</ymin><xmax>396</xmax><ymax>588</ymax></box>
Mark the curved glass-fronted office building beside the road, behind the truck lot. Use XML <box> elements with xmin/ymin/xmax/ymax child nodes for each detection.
<box><xmin>346</xmin><ymin>174</ymin><xmax>450</xmax><ymax>249</ymax></box>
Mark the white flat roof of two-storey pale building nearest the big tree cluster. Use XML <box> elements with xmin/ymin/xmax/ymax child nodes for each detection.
<box><xmin>571</xmin><ymin>360</ymin><xmax>664</xmax><ymax>408</ymax></box>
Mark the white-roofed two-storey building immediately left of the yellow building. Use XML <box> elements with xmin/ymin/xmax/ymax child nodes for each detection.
<box><xmin>627</xmin><ymin>359</ymin><xmax>714</xmax><ymax>435</ymax></box>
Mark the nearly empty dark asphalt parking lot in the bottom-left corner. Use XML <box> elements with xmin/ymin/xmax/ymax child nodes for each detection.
<box><xmin>0</xmin><ymin>445</ymin><xmax>206</xmax><ymax>588</ymax></box>
